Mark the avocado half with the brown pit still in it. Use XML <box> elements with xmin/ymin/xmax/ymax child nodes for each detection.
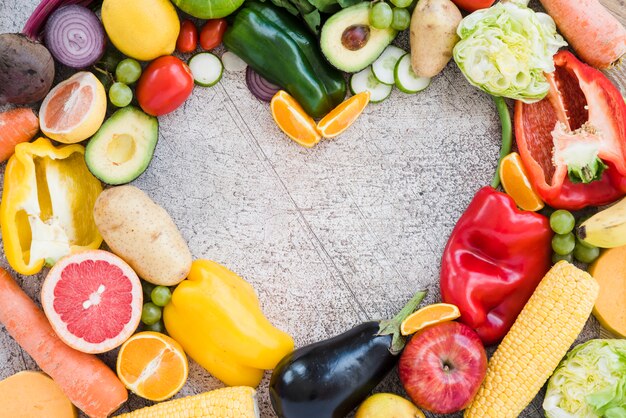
<box><xmin>320</xmin><ymin>2</ymin><xmax>398</xmax><ymax>73</ymax></box>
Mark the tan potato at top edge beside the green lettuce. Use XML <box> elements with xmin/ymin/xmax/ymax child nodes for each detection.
<box><xmin>410</xmin><ymin>0</ymin><xmax>463</xmax><ymax>77</ymax></box>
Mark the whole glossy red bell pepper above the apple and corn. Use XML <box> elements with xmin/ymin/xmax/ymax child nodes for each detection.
<box><xmin>440</xmin><ymin>186</ymin><xmax>552</xmax><ymax>345</ymax></box>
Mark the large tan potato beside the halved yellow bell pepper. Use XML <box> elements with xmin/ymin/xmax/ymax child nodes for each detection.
<box><xmin>94</xmin><ymin>186</ymin><xmax>191</xmax><ymax>286</ymax></box>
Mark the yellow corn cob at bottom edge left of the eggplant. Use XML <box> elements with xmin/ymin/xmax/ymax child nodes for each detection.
<box><xmin>115</xmin><ymin>386</ymin><xmax>259</xmax><ymax>418</ymax></box>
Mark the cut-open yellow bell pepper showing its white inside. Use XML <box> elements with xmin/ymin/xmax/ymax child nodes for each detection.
<box><xmin>0</xmin><ymin>138</ymin><xmax>102</xmax><ymax>275</ymax></box>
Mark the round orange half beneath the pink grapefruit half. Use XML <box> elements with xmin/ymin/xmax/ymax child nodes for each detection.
<box><xmin>117</xmin><ymin>331</ymin><xmax>189</xmax><ymax>401</ymax></box>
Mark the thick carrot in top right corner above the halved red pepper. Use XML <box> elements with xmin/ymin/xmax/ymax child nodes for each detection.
<box><xmin>541</xmin><ymin>0</ymin><xmax>626</xmax><ymax>69</ymax></box>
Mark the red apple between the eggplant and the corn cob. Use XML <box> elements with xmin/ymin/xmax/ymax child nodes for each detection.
<box><xmin>398</xmin><ymin>322</ymin><xmax>487</xmax><ymax>414</ymax></box>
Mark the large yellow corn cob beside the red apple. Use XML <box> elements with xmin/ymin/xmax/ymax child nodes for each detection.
<box><xmin>464</xmin><ymin>261</ymin><xmax>599</xmax><ymax>418</ymax></box>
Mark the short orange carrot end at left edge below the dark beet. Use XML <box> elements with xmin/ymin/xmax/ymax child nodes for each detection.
<box><xmin>0</xmin><ymin>107</ymin><xmax>39</xmax><ymax>162</ymax></box>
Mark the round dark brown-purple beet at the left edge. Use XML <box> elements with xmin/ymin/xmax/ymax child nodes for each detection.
<box><xmin>0</xmin><ymin>33</ymin><xmax>54</xmax><ymax>105</ymax></box>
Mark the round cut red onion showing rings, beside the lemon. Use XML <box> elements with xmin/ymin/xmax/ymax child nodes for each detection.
<box><xmin>44</xmin><ymin>4</ymin><xmax>106</xmax><ymax>68</ymax></box>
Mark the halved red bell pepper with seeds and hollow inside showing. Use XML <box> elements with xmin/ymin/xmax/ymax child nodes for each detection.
<box><xmin>515</xmin><ymin>51</ymin><xmax>626</xmax><ymax>210</ymax></box>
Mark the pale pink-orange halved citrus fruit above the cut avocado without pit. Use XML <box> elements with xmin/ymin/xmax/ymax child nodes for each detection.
<box><xmin>39</xmin><ymin>71</ymin><xmax>107</xmax><ymax>144</ymax></box>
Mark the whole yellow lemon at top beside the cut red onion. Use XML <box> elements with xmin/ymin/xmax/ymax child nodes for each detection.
<box><xmin>102</xmin><ymin>0</ymin><xmax>180</xmax><ymax>61</ymax></box>
